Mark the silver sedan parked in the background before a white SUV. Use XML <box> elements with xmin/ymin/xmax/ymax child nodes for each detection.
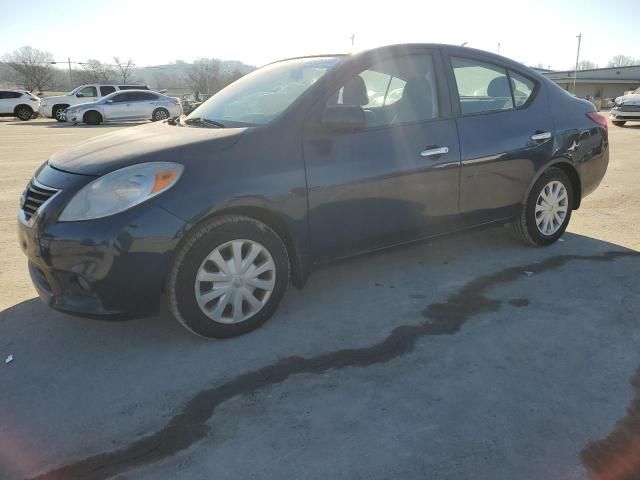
<box><xmin>65</xmin><ymin>90</ymin><xmax>182</xmax><ymax>125</ymax></box>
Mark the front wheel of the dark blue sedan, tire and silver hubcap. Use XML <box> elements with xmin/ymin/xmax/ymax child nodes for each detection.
<box><xmin>167</xmin><ymin>216</ymin><xmax>289</xmax><ymax>338</ymax></box>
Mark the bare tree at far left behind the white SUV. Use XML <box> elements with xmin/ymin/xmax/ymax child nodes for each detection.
<box><xmin>3</xmin><ymin>47</ymin><xmax>55</xmax><ymax>91</ymax></box>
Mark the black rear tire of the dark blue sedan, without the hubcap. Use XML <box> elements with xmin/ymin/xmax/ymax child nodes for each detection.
<box><xmin>513</xmin><ymin>167</ymin><xmax>574</xmax><ymax>247</ymax></box>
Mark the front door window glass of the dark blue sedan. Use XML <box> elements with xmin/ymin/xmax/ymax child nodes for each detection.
<box><xmin>327</xmin><ymin>55</ymin><xmax>438</xmax><ymax>128</ymax></box>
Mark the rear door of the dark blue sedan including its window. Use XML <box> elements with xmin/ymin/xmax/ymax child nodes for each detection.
<box><xmin>449</xmin><ymin>51</ymin><xmax>554</xmax><ymax>224</ymax></box>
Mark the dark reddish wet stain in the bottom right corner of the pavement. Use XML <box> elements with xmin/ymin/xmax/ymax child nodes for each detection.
<box><xmin>580</xmin><ymin>368</ymin><xmax>640</xmax><ymax>480</ymax></box>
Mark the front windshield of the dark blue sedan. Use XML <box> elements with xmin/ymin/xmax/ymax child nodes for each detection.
<box><xmin>187</xmin><ymin>57</ymin><xmax>341</xmax><ymax>125</ymax></box>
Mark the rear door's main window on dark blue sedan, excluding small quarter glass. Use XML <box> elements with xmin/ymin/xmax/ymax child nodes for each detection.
<box><xmin>451</xmin><ymin>58</ymin><xmax>516</xmax><ymax>114</ymax></box>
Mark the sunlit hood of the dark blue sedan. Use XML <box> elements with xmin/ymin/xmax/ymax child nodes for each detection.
<box><xmin>49</xmin><ymin>122</ymin><xmax>247</xmax><ymax>176</ymax></box>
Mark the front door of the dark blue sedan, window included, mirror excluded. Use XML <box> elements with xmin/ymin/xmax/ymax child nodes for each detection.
<box><xmin>303</xmin><ymin>50</ymin><xmax>460</xmax><ymax>262</ymax></box>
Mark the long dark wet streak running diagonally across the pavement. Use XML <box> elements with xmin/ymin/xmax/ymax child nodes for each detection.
<box><xmin>33</xmin><ymin>251</ymin><xmax>640</xmax><ymax>480</ymax></box>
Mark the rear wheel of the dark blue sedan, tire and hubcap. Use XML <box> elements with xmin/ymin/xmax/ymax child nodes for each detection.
<box><xmin>513</xmin><ymin>168</ymin><xmax>573</xmax><ymax>246</ymax></box>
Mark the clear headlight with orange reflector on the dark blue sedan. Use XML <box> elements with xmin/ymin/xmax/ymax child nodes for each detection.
<box><xmin>59</xmin><ymin>162</ymin><xmax>184</xmax><ymax>222</ymax></box>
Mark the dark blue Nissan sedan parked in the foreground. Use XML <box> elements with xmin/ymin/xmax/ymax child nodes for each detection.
<box><xmin>19</xmin><ymin>45</ymin><xmax>609</xmax><ymax>338</ymax></box>
